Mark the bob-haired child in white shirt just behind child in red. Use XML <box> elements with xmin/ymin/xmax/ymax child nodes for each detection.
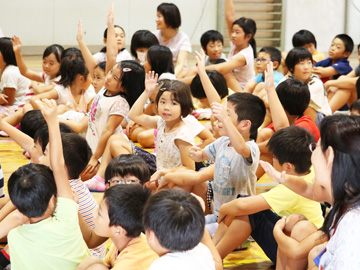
<box><xmin>279</xmin><ymin>48</ymin><xmax>332</xmax><ymax>126</ymax></box>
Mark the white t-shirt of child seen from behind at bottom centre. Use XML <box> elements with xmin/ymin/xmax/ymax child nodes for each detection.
<box><xmin>149</xmin><ymin>243</ymin><xmax>215</xmax><ymax>270</ymax></box>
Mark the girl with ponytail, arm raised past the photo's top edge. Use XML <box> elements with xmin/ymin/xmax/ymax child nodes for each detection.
<box><xmin>206</xmin><ymin>0</ymin><xmax>256</xmax><ymax>92</ymax></box>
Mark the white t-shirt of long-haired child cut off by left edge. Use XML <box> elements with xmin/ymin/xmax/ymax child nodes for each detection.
<box><xmin>0</xmin><ymin>65</ymin><xmax>30</xmax><ymax>107</ymax></box>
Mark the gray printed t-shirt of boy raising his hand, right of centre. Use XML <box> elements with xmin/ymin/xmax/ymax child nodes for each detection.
<box><xmin>205</xmin><ymin>136</ymin><xmax>260</xmax><ymax>215</ymax></box>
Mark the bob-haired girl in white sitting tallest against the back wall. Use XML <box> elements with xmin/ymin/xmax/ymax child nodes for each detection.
<box><xmin>153</xmin><ymin>3</ymin><xmax>191</xmax><ymax>75</ymax></box>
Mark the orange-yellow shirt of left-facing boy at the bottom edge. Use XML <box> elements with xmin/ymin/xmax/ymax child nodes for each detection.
<box><xmin>104</xmin><ymin>233</ymin><xmax>159</xmax><ymax>270</ymax></box>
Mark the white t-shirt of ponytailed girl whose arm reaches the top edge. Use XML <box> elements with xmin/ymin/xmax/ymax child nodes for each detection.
<box><xmin>228</xmin><ymin>42</ymin><xmax>255</xmax><ymax>88</ymax></box>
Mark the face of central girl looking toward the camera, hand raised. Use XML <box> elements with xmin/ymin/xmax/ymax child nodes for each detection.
<box><xmin>158</xmin><ymin>91</ymin><xmax>181</xmax><ymax>122</ymax></box>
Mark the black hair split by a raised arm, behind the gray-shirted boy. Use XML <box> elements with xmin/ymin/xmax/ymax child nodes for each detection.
<box><xmin>190</xmin><ymin>70</ymin><xmax>229</xmax><ymax>99</ymax></box>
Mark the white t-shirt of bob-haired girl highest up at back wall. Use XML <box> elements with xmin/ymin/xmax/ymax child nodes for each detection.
<box><xmin>153</xmin><ymin>30</ymin><xmax>191</xmax><ymax>65</ymax></box>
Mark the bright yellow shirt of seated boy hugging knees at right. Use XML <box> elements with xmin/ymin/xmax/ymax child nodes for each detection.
<box><xmin>261</xmin><ymin>170</ymin><xmax>324</xmax><ymax>228</ymax></box>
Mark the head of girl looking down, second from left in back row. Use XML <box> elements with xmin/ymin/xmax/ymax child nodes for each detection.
<box><xmin>42</xmin><ymin>44</ymin><xmax>64</xmax><ymax>78</ymax></box>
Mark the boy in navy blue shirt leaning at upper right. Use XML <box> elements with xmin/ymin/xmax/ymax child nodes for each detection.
<box><xmin>312</xmin><ymin>34</ymin><xmax>354</xmax><ymax>82</ymax></box>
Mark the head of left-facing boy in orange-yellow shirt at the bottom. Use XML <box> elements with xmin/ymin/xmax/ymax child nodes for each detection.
<box><xmin>95</xmin><ymin>185</ymin><xmax>151</xmax><ymax>238</ymax></box>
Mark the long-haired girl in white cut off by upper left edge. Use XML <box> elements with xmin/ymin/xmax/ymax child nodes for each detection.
<box><xmin>0</xmin><ymin>37</ymin><xmax>30</xmax><ymax>116</ymax></box>
